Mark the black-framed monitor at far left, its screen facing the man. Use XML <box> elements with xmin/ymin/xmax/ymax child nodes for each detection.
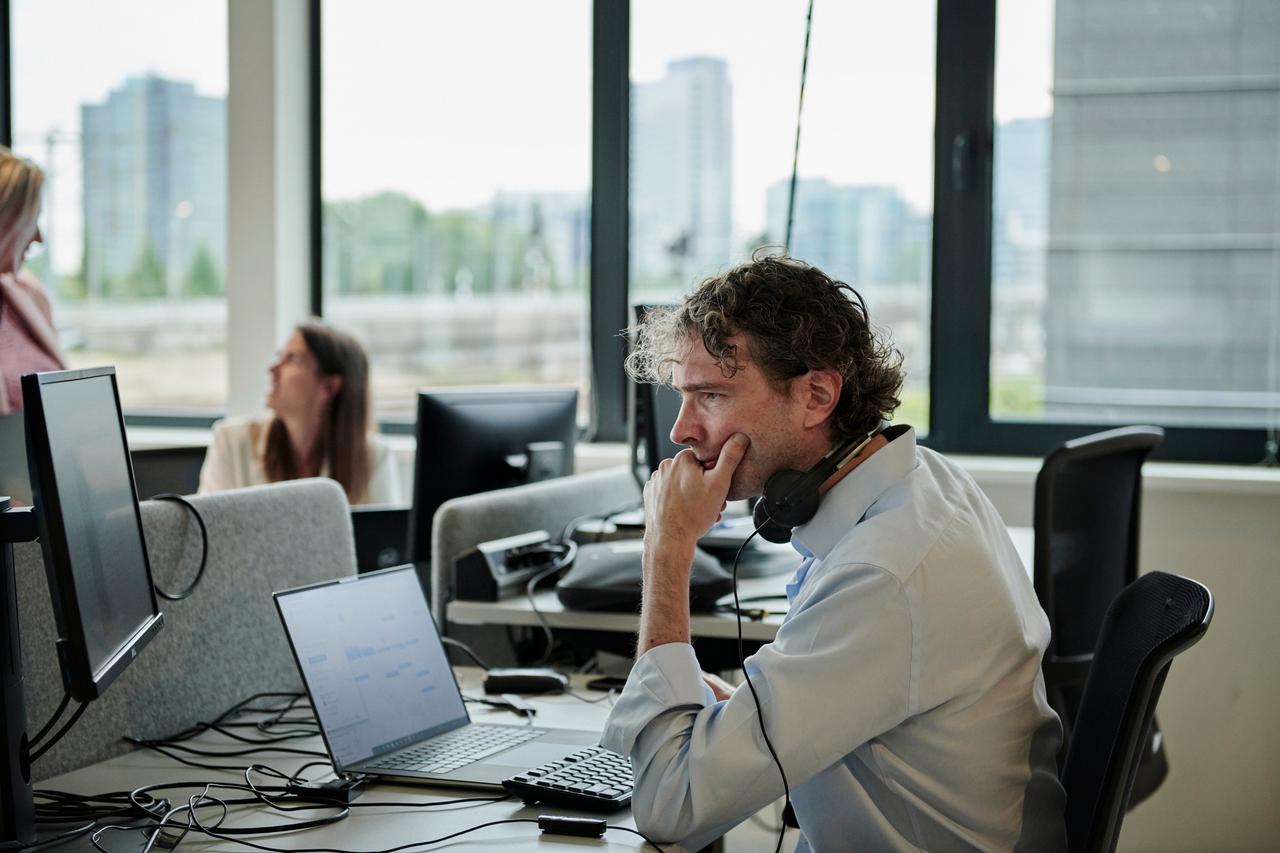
<box><xmin>22</xmin><ymin>368</ymin><xmax>163</xmax><ymax>702</ymax></box>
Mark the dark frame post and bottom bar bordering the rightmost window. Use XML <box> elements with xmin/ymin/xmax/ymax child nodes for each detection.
<box><xmin>924</xmin><ymin>0</ymin><xmax>1267</xmax><ymax>464</ymax></box>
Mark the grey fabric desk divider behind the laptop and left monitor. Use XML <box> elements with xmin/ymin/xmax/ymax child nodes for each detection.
<box><xmin>14</xmin><ymin>479</ymin><xmax>356</xmax><ymax>780</ymax></box>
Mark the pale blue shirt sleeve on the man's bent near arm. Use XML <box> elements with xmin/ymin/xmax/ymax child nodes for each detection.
<box><xmin>600</xmin><ymin>558</ymin><xmax>914</xmax><ymax>849</ymax></box>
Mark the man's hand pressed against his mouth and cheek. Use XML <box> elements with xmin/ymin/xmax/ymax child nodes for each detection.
<box><xmin>644</xmin><ymin>433</ymin><xmax>751</xmax><ymax>548</ymax></box>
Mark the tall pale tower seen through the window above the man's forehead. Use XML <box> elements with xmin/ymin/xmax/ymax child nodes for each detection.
<box><xmin>631</xmin><ymin>56</ymin><xmax>732</xmax><ymax>289</ymax></box>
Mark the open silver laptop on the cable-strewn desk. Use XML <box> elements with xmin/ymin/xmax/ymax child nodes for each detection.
<box><xmin>275</xmin><ymin>565</ymin><xmax>599</xmax><ymax>790</ymax></box>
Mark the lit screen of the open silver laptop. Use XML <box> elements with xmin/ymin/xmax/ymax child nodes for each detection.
<box><xmin>275</xmin><ymin>566</ymin><xmax>468</xmax><ymax>767</ymax></box>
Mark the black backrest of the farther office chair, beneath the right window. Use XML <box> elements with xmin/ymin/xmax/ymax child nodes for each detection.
<box><xmin>1033</xmin><ymin>427</ymin><xmax>1165</xmax><ymax>671</ymax></box>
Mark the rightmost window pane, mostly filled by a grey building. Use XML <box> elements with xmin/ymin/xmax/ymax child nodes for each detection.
<box><xmin>989</xmin><ymin>0</ymin><xmax>1280</xmax><ymax>448</ymax></box>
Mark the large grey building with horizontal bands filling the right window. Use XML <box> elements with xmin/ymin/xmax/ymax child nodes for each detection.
<box><xmin>1044</xmin><ymin>0</ymin><xmax>1280</xmax><ymax>427</ymax></box>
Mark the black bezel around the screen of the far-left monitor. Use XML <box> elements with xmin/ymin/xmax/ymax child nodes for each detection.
<box><xmin>22</xmin><ymin>366</ymin><xmax>164</xmax><ymax>702</ymax></box>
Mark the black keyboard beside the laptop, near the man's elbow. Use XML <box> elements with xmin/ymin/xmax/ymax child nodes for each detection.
<box><xmin>502</xmin><ymin>747</ymin><xmax>631</xmax><ymax>812</ymax></box>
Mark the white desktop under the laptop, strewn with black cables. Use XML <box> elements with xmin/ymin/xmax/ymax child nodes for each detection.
<box><xmin>36</xmin><ymin>667</ymin><xmax>678</xmax><ymax>853</ymax></box>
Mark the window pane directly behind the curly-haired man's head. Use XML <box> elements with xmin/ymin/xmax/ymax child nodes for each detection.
<box><xmin>630</xmin><ymin>0</ymin><xmax>934</xmax><ymax>432</ymax></box>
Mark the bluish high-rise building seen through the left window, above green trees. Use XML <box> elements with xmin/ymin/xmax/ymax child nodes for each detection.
<box><xmin>81</xmin><ymin>76</ymin><xmax>227</xmax><ymax>298</ymax></box>
